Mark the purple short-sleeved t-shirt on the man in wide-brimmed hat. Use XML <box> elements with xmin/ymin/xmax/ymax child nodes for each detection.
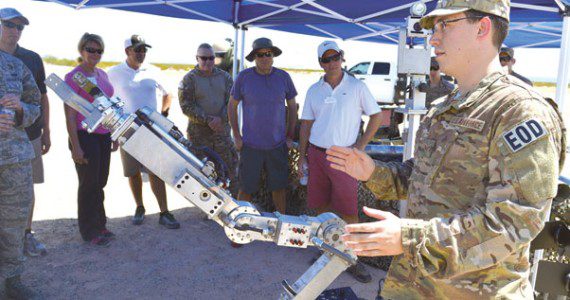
<box><xmin>231</xmin><ymin>68</ymin><xmax>297</xmax><ymax>150</ymax></box>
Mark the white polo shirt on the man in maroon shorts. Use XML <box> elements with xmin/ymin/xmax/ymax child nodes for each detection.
<box><xmin>301</xmin><ymin>73</ymin><xmax>380</xmax><ymax>148</ymax></box>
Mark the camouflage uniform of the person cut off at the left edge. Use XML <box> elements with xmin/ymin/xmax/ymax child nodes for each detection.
<box><xmin>0</xmin><ymin>51</ymin><xmax>40</xmax><ymax>278</ymax></box>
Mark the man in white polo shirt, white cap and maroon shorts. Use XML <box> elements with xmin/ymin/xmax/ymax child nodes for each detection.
<box><xmin>298</xmin><ymin>41</ymin><xmax>381</xmax><ymax>282</ymax></box>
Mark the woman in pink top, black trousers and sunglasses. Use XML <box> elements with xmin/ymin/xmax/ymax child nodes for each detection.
<box><xmin>65</xmin><ymin>33</ymin><xmax>117</xmax><ymax>246</ymax></box>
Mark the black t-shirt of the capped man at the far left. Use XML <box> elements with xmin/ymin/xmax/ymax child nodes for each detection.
<box><xmin>14</xmin><ymin>45</ymin><xmax>47</xmax><ymax>141</ymax></box>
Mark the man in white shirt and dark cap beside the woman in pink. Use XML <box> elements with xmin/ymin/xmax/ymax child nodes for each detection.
<box><xmin>108</xmin><ymin>35</ymin><xmax>180</xmax><ymax>229</ymax></box>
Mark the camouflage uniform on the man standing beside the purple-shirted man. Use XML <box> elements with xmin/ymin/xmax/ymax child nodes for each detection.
<box><xmin>178</xmin><ymin>68</ymin><xmax>238</xmax><ymax>196</ymax></box>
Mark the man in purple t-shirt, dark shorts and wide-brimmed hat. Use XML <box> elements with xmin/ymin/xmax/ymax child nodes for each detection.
<box><xmin>228</xmin><ymin>38</ymin><xmax>297</xmax><ymax>213</ymax></box>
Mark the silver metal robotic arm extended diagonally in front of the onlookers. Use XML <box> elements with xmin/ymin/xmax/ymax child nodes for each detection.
<box><xmin>46</xmin><ymin>73</ymin><xmax>357</xmax><ymax>299</ymax></box>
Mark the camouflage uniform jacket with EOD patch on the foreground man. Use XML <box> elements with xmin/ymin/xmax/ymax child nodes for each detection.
<box><xmin>367</xmin><ymin>72</ymin><xmax>566</xmax><ymax>299</ymax></box>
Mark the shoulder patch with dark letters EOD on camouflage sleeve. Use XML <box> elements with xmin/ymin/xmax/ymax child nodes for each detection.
<box><xmin>503</xmin><ymin>119</ymin><xmax>547</xmax><ymax>152</ymax></box>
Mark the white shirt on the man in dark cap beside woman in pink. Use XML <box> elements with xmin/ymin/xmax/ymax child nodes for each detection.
<box><xmin>107</xmin><ymin>62</ymin><xmax>167</xmax><ymax>113</ymax></box>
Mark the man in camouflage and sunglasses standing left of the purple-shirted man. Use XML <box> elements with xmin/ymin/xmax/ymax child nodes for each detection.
<box><xmin>178</xmin><ymin>44</ymin><xmax>238</xmax><ymax>197</ymax></box>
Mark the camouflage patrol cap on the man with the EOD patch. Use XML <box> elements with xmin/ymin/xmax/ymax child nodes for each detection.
<box><xmin>420</xmin><ymin>0</ymin><xmax>511</xmax><ymax>29</ymax></box>
